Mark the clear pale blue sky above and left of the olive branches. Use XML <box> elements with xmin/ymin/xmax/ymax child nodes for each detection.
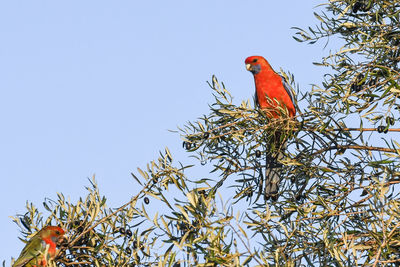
<box><xmin>0</xmin><ymin>0</ymin><xmax>328</xmax><ymax>263</ymax></box>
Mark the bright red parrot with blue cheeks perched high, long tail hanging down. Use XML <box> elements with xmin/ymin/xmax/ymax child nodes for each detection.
<box><xmin>245</xmin><ymin>56</ymin><xmax>296</xmax><ymax>199</ymax></box>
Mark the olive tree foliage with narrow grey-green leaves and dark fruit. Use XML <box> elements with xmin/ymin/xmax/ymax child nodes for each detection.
<box><xmin>7</xmin><ymin>0</ymin><xmax>400</xmax><ymax>266</ymax></box>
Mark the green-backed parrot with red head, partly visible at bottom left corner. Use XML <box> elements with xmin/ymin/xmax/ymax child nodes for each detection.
<box><xmin>12</xmin><ymin>226</ymin><xmax>65</xmax><ymax>267</ymax></box>
